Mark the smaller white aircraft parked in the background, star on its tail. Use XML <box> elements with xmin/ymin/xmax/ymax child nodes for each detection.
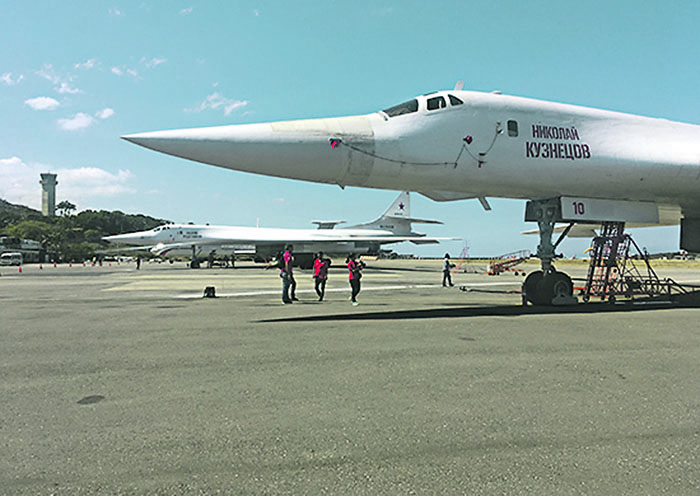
<box><xmin>103</xmin><ymin>192</ymin><xmax>457</xmax><ymax>267</ymax></box>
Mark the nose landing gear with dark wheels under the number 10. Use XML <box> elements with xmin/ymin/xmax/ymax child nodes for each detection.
<box><xmin>522</xmin><ymin>198</ymin><xmax>578</xmax><ymax>305</ymax></box>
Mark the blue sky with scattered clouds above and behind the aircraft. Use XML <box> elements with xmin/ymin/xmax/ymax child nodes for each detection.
<box><xmin>0</xmin><ymin>0</ymin><xmax>700</xmax><ymax>256</ymax></box>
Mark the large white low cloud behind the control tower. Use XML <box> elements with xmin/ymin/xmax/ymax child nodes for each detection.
<box><xmin>0</xmin><ymin>157</ymin><xmax>136</xmax><ymax>210</ymax></box>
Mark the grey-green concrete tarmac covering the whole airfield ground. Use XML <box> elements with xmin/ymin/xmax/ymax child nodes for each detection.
<box><xmin>0</xmin><ymin>260</ymin><xmax>700</xmax><ymax>495</ymax></box>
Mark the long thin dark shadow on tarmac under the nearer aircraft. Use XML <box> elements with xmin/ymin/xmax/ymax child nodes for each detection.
<box><xmin>259</xmin><ymin>301</ymin><xmax>700</xmax><ymax>322</ymax></box>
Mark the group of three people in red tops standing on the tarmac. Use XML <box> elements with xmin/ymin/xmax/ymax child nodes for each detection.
<box><xmin>278</xmin><ymin>245</ymin><xmax>365</xmax><ymax>305</ymax></box>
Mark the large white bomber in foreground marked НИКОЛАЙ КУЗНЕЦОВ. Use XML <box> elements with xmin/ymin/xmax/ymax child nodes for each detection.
<box><xmin>123</xmin><ymin>82</ymin><xmax>700</xmax><ymax>304</ymax></box>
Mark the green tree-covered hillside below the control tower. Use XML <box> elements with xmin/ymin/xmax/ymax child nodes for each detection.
<box><xmin>0</xmin><ymin>199</ymin><xmax>171</xmax><ymax>262</ymax></box>
